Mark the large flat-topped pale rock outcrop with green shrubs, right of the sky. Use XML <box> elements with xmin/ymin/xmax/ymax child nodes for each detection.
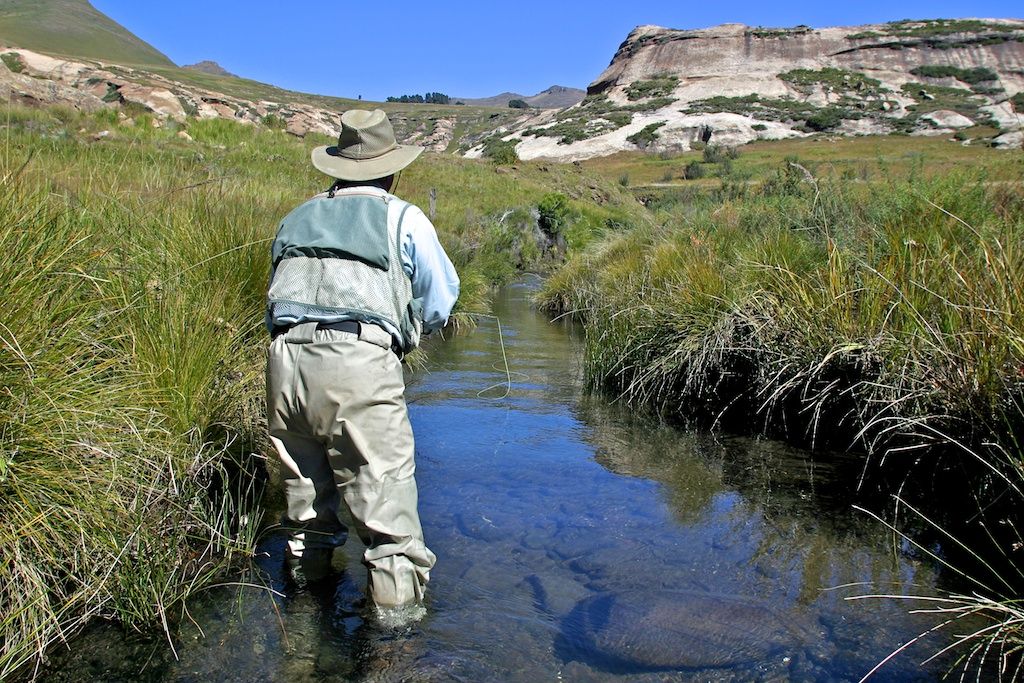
<box><xmin>477</xmin><ymin>19</ymin><xmax>1024</xmax><ymax>161</ymax></box>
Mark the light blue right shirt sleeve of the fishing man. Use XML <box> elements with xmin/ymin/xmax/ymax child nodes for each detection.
<box><xmin>401</xmin><ymin>206</ymin><xmax>459</xmax><ymax>332</ymax></box>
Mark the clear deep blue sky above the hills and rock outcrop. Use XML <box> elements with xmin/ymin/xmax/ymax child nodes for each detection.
<box><xmin>92</xmin><ymin>0</ymin><xmax>1024</xmax><ymax>100</ymax></box>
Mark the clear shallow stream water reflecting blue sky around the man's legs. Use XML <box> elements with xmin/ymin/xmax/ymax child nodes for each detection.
<box><xmin>45</xmin><ymin>276</ymin><xmax>974</xmax><ymax>681</ymax></box>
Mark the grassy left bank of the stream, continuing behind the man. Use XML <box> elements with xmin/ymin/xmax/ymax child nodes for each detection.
<box><xmin>0</xmin><ymin>108</ymin><xmax>645</xmax><ymax>678</ymax></box>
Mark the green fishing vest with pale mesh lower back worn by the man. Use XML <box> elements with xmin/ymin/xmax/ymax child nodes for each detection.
<box><xmin>267</xmin><ymin>193</ymin><xmax>423</xmax><ymax>353</ymax></box>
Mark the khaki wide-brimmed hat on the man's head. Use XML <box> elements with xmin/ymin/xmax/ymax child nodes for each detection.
<box><xmin>312</xmin><ymin>110</ymin><xmax>423</xmax><ymax>180</ymax></box>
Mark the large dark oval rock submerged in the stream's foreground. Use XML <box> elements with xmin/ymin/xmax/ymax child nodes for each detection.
<box><xmin>561</xmin><ymin>591</ymin><xmax>805</xmax><ymax>672</ymax></box>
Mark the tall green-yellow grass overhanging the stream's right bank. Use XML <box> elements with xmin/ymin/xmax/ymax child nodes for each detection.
<box><xmin>541</xmin><ymin>164</ymin><xmax>1024</xmax><ymax>671</ymax></box>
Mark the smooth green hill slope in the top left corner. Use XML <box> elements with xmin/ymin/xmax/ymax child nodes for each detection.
<box><xmin>0</xmin><ymin>0</ymin><xmax>174</xmax><ymax>67</ymax></box>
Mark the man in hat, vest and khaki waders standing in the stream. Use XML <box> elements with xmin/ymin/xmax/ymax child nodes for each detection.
<box><xmin>266</xmin><ymin>110</ymin><xmax>459</xmax><ymax>613</ymax></box>
